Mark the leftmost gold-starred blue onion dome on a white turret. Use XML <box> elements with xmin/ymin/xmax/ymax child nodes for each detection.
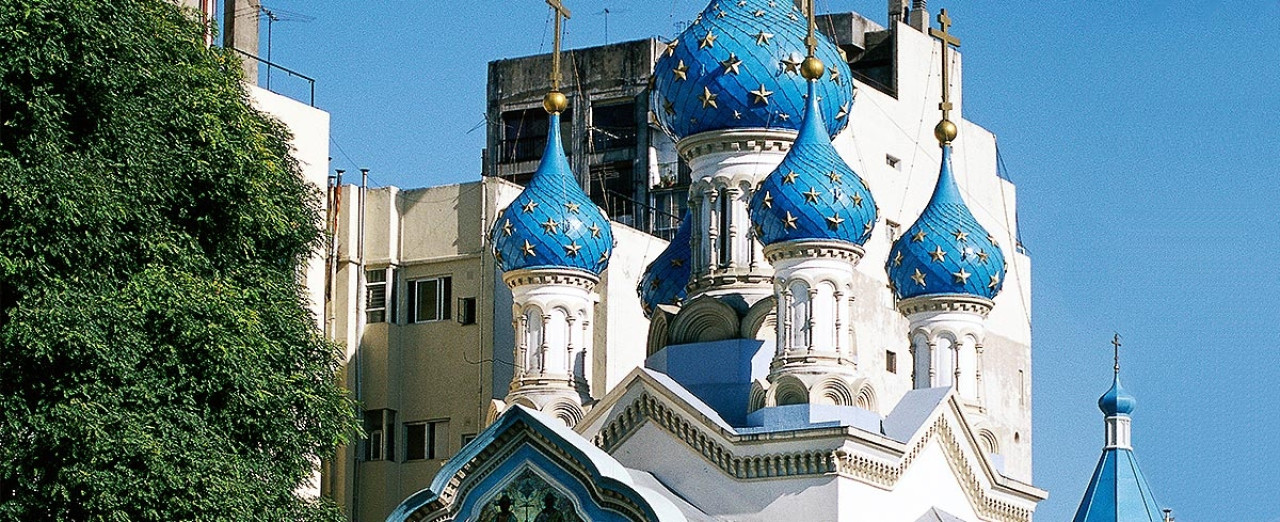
<box><xmin>490</xmin><ymin>114</ymin><xmax>613</xmax><ymax>275</ymax></box>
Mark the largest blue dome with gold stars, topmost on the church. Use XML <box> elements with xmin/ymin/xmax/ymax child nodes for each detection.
<box><xmin>652</xmin><ymin>0</ymin><xmax>852</xmax><ymax>139</ymax></box>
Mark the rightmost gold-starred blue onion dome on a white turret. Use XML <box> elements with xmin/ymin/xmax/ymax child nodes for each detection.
<box><xmin>884</xmin><ymin>142</ymin><xmax>1005</xmax><ymax>299</ymax></box>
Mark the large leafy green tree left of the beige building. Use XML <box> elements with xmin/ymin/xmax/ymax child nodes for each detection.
<box><xmin>0</xmin><ymin>0</ymin><xmax>356</xmax><ymax>521</ymax></box>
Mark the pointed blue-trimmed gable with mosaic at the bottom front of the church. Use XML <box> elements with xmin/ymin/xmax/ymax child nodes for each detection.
<box><xmin>388</xmin><ymin>406</ymin><xmax>684</xmax><ymax>522</ymax></box>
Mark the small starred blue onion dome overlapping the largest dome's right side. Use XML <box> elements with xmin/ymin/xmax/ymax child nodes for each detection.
<box><xmin>749</xmin><ymin>82</ymin><xmax>877</xmax><ymax>246</ymax></box>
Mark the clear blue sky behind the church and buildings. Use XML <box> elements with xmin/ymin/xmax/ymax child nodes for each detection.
<box><xmin>241</xmin><ymin>0</ymin><xmax>1280</xmax><ymax>522</ymax></box>
